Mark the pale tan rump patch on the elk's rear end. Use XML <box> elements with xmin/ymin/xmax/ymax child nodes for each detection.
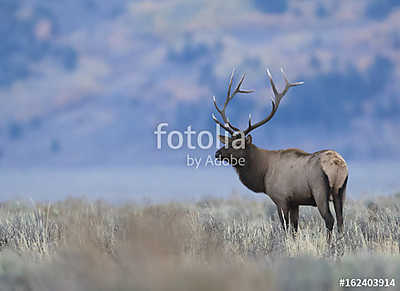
<box><xmin>320</xmin><ymin>151</ymin><xmax>348</xmax><ymax>192</ymax></box>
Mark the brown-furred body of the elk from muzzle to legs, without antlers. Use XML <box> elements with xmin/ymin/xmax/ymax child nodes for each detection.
<box><xmin>216</xmin><ymin>141</ymin><xmax>348</xmax><ymax>237</ymax></box>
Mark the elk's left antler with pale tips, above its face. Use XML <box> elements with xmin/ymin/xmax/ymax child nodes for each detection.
<box><xmin>212</xmin><ymin>70</ymin><xmax>254</xmax><ymax>134</ymax></box>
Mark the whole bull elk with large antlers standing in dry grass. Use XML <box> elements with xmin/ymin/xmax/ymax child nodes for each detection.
<box><xmin>212</xmin><ymin>69</ymin><xmax>348</xmax><ymax>241</ymax></box>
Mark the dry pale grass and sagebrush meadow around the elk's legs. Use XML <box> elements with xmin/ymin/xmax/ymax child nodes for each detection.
<box><xmin>0</xmin><ymin>195</ymin><xmax>400</xmax><ymax>291</ymax></box>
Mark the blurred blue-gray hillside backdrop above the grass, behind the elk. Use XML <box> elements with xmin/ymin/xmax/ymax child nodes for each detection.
<box><xmin>0</xmin><ymin>0</ymin><xmax>400</xmax><ymax>199</ymax></box>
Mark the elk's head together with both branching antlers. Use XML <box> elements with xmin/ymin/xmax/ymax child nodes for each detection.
<box><xmin>212</xmin><ymin>69</ymin><xmax>304</xmax><ymax>164</ymax></box>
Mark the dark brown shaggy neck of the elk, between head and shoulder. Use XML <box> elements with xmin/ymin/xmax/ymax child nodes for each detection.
<box><xmin>235</xmin><ymin>144</ymin><xmax>268</xmax><ymax>193</ymax></box>
